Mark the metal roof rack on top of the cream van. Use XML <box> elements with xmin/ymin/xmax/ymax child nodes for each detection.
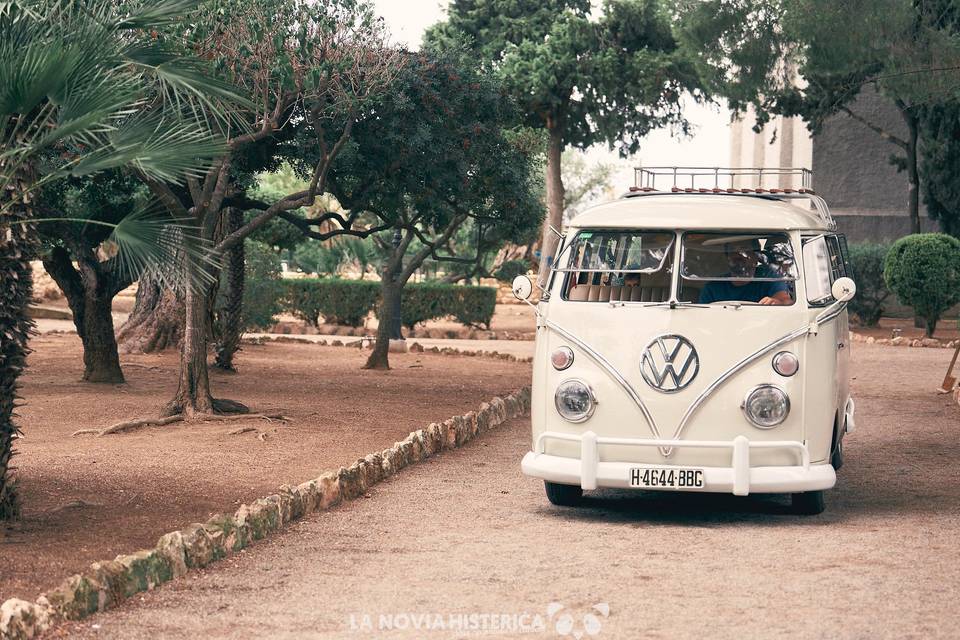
<box><xmin>626</xmin><ymin>167</ymin><xmax>837</xmax><ymax>229</ymax></box>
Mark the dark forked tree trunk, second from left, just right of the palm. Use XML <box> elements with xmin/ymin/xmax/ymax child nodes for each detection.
<box><xmin>43</xmin><ymin>247</ymin><xmax>128</xmax><ymax>384</ymax></box>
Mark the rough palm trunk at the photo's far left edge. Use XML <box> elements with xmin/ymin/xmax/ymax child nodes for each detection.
<box><xmin>0</xmin><ymin>178</ymin><xmax>36</xmax><ymax>520</ymax></box>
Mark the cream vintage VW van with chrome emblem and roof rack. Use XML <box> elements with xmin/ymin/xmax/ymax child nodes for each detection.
<box><xmin>514</xmin><ymin>167</ymin><xmax>855</xmax><ymax>513</ymax></box>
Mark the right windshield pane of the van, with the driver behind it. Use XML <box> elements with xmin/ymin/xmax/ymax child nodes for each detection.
<box><xmin>678</xmin><ymin>232</ymin><xmax>797</xmax><ymax>305</ymax></box>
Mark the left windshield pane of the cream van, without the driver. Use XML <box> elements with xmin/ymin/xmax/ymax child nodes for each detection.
<box><xmin>557</xmin><ymin>231</ymin><xmax>675</xmax><ymax>302</ymax></box>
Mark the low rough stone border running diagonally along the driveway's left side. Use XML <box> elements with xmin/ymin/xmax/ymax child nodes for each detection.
<box><xmin>0</xmin><ymin>387</ymin><xmax>530</xmax><ymax>640</ymax></box>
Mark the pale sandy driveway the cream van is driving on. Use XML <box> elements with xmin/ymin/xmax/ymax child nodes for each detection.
<box><xmin>51</xmin><ymin>344</ymin><xmax>960</xmax><ymax>639</ymax></box>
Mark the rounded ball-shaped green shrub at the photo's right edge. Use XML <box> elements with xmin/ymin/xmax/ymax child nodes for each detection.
<box><xmin>883</xmin><ymin>233</ymin><xmax>960</xmax><ymax>336</ymax></box>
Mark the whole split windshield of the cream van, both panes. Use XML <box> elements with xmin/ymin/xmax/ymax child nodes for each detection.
<box><xmin>557</xmin><ymin>231</ymin><xmax>797</xmax><ymax>305</ymax></box>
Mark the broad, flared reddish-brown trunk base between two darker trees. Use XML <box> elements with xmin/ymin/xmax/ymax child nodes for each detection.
<box><xmin>117</xmin><ymin>273</ymin><xmax>186</xmax><ymax>353</ymax></box>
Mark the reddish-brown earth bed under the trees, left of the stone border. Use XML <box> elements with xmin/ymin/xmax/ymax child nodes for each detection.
<box><xmin>0</xmin><ymin>335</ymin><xmax>530</xmax><ymax>602</ymax></box>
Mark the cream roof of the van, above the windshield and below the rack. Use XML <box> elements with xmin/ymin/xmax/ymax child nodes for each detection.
<box><xmin>570</xmin><ymin>192</ymin><xmax>834</xmax><ymax>231</ymax></box>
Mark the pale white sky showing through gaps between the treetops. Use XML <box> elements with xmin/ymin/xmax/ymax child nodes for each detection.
<box><xmin>375</xmin><ymin>0</ymin><xmax>730</xmax><ymax>198</ymax></box>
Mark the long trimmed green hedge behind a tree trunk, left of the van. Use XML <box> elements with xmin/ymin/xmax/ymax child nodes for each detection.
<box><xmin>284</xmin><ymin>278</ymin><xmax>497</xmax><ymax>329</ymax></box>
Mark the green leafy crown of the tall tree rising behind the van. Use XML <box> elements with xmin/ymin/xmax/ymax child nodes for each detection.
<box><xmin>425</xmin><ymin>0</ymin><xmax>699</xmax><ymax>154</ymax></box>
